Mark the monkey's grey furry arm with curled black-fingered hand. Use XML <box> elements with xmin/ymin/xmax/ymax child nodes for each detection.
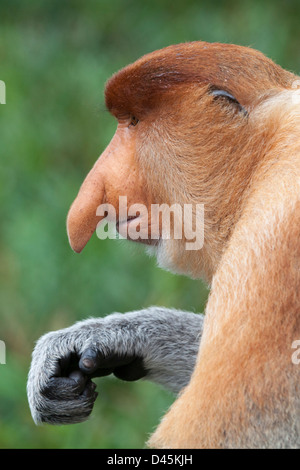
<box><xmin>27</xmin><ymin>307</ymin><xmax>204</xmax><ymax>424</ymax></box>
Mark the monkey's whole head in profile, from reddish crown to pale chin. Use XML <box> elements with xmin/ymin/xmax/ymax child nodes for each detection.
<box><xmin>67</xmin><ymin>42</ymin><xmax>295</xmax><ymax>279</ymax></box>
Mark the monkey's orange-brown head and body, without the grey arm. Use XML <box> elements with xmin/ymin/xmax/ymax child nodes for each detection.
<box><xmin>68</xmin><ymin>42</ymin><xmax>300</xmax><ymax>448</ymax></box>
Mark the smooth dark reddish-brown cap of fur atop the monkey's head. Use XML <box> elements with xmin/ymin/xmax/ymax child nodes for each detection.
<box><xmin>105</xmin><ymin>42</ymin><xmax>292</xmax><ymax>117</ymax></box>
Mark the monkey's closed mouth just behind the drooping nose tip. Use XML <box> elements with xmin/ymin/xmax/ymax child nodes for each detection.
<box><xmin>116</xmin><ymin>215</ymin><xmax>159</xmax><ymax>245</ymax></box>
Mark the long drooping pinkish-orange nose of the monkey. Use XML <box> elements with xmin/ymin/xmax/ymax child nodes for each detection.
<box><xmin>67</xmin><ymin>165</ymin><xmax>105</xmax><ymax>253</ymax></box>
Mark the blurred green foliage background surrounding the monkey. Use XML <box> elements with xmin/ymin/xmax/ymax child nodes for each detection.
<box><xmin>0</xmin><ymin>0</ymin><xmax>300</xmax><ymax>448</ymax></box>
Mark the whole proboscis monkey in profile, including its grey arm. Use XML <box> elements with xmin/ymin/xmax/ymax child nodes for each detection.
<box><xmin>28</xmin><ymin>42</ymin><xmax>300</xmax><ymax>448</ymax></box>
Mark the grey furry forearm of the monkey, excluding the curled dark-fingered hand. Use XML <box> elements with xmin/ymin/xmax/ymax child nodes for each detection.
<box><xmin>98</xmin><ymin>307</ymin><xmax>204</xmax><ymax>393</ymax></box>
